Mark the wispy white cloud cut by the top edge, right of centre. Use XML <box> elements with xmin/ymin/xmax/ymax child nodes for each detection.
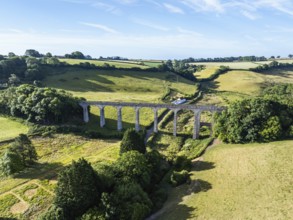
<box><xmin>181</xmin><ymin>0</ymin><xmax>225</xmax><ymax>13</ymax></box>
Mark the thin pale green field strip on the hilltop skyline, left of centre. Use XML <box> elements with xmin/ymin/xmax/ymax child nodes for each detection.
<box><xmin>59</xmin><ymin>59</ymin><xmax>149</xmax><ymax>69</ymax></box>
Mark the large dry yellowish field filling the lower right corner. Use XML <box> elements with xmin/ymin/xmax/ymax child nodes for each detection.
<box><xmin>156</xmin><ymin>140</ymin><xmax>293</xmax><ymax>220</ymax></box>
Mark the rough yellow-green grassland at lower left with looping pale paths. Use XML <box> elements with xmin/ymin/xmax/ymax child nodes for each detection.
<box><xmin>0</xmin><ymin>135</ymin><xmax>119</xmax><ymax>219</ymax></box>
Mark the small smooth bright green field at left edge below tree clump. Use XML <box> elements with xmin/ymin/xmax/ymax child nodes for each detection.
<box><xmin>0</xmin><ymin>116</ymin><xmax>28</xmax><ymax>141</ymax></box>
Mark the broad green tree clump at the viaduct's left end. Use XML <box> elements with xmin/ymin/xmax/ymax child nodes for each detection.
<box><xmin>0</xmin><ymin>85</ymin><xmax>82</xmax><ymax>124</ymax></box>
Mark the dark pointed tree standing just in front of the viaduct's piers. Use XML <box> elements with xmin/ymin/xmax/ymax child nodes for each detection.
<box><xmin>120</xmin><ymin>128</ymin><xmax>146</xmax><ymax>154</ymax></box>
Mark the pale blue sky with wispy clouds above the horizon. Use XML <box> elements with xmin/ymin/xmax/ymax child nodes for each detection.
<box><xmin>0</xmin><ymin>0</ymin><xmax>293</xmax><ymax>59</ymax></box>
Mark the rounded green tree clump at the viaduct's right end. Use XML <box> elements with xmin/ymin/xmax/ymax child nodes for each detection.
<box><xmin>215</xmin><ymin>98</ymin><xmax>293</xmax><ymax>143</ymax></box>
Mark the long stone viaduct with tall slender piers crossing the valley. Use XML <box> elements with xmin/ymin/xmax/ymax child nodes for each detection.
<box><xmin>79</xmin><ymin>101</ymin><xmax>224</xmax><ymax>139</ymax></box>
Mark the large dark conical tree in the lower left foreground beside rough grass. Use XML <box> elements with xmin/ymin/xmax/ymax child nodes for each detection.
<box><xmin>55</xmin><ymin>159</ymin><xmax>102</xmax><ymax>218</ymax></box>
